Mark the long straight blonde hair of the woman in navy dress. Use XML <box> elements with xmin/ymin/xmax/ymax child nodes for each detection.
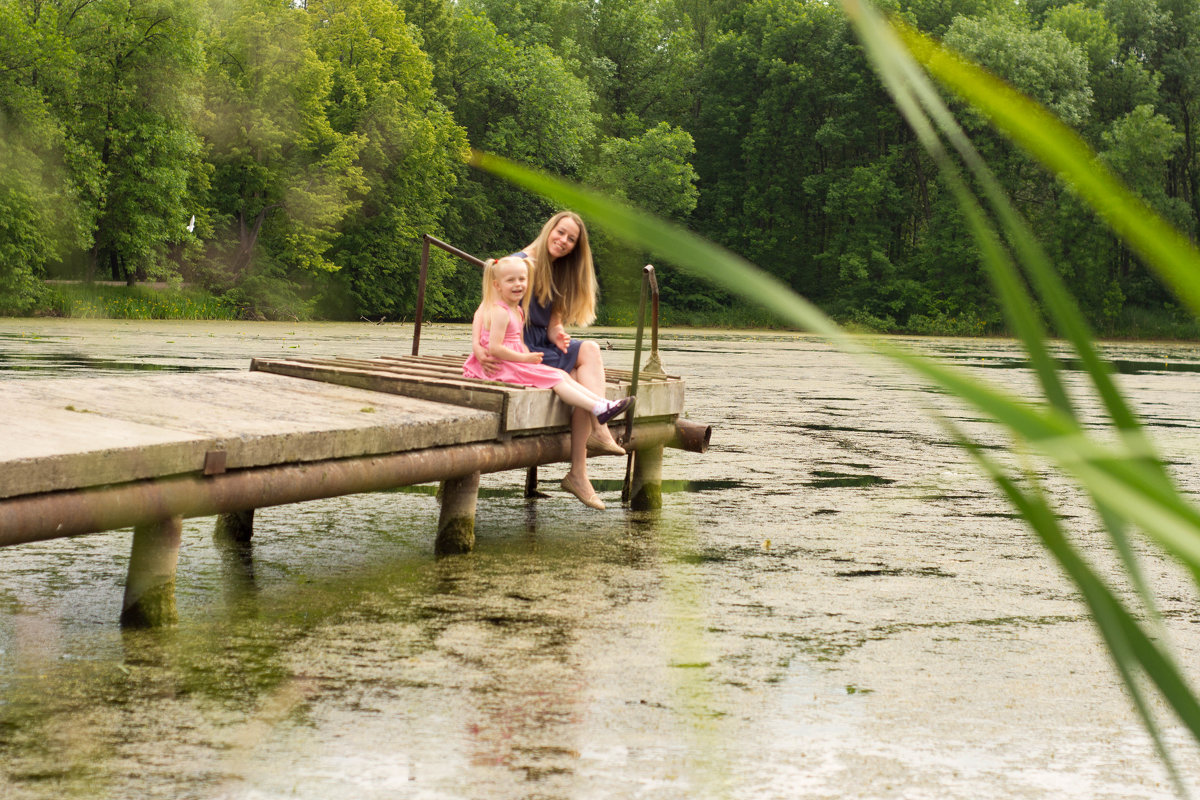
<box><xmin>528</xmin><ymin>211</ymin><xmax>600</xmax><ymax>325</ymax></box>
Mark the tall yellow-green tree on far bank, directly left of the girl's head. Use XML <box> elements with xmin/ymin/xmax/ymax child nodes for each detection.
<box><xmin>308</xmin><ymin>0</ymin><xmax>467</xmax><ymax>319</ymax></box>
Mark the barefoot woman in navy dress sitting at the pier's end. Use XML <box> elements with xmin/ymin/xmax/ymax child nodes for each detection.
<box><xmin>481</xmin><ymin>211</ymin><xmax>625</xmax><ymax>509</ymax></box>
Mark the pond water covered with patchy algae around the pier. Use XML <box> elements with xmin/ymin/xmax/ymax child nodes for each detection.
<box><xmin>0</xmin><ymin>320</ymin><xmax>1200</xmax><ymax>800</ymax></box>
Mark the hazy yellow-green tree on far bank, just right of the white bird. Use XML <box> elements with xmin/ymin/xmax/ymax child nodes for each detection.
<box><xmin>203</xmin><ymin>0</ymin><xmax>366</xmax><ymax>315</ymax></box>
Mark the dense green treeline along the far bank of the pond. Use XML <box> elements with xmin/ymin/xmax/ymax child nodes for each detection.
<box><xmin>0</xmin><ymin>0</ymin><xmax>1200</xmax><ymax>332</ymax></box>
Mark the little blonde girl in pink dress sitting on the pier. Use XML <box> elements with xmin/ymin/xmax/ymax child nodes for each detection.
<box><xmin>462</xmin><ymin>255</ymin><xmax>634</xmax><ymax>509</ymax></box>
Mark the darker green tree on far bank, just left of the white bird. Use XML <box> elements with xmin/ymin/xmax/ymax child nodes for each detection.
<box><xmin>65</xmin><ymin>0</ymin><xmax>200</xmax><ymax>283</ymax></box>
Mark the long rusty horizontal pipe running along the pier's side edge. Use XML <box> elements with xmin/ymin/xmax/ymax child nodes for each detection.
<box><xmin>0</xmin><ymin>421</ymin><xmax>691</xmax><ymax>546</ymax></box>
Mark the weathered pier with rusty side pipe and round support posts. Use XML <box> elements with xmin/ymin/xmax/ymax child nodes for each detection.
<box><xmin>0</xmin><ymin>356</ymin><xmax>709</xmax><ymax>625</ymax></box>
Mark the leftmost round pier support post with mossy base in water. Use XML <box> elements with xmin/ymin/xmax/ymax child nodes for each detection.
<box><xmin>121</xmin><ymin>517</ymin><xmax>184</xmax><ymax>627</ymax></box>
